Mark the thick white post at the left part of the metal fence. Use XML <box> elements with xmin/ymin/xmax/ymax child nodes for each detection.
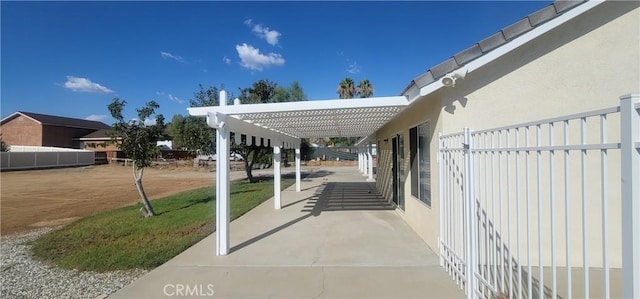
<box><xmin>463</xmin><ymin>128</ymin><xmax>477</xmax><ymax>298</ymax></box>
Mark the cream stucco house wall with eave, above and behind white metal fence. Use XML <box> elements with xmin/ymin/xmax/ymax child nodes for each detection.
<box><xmin>376</xmin><ymin>1</ymin><xmax>640</xmax><ymax>267</ymax></box>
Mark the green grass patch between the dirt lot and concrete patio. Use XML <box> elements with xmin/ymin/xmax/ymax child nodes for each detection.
<box><xmin>32</xmin><ymin>179</ymin><xmax>294</xmax><ymax>272</ymax></box>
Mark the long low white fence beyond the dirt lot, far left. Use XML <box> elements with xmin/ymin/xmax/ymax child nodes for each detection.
<box><xmin>0</xmin><ymin>145</ymin><xmax>95</xmax><ymax>171</ymax></box>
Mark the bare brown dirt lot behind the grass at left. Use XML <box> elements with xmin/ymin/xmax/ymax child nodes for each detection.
<box><xmin>0</xmin><ymin>165</ymin><xmax>220</xmax><ymax>235</ymax></box>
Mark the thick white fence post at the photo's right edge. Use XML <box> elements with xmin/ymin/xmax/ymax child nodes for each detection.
<box><xmin>620</xmin><ymin>94</ymin><xmax>640</xmax><ymax>298</ymax></box>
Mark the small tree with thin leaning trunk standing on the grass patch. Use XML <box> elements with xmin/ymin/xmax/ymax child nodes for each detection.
<box><xmin>108</xmin><ymin>97</ymin><xmax>165</xmax><ymax>217</ymax></box>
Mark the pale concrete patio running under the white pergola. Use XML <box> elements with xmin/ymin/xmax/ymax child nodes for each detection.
<box><xmin>109</xmin><ymin>167</ymin><xmax>464</xmax><ymax>298</ymax></box>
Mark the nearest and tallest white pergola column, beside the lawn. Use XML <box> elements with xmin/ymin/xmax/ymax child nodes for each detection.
<box><xmin>216</xmin><ymin>90</ymin><xmax>230</xmax><ymax>255</ymax></box>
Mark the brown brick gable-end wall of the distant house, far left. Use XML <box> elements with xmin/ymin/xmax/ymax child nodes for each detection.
<box><xmin>0</xmin><ymin>115</ymin><xmax>42</xmax><ymax>146</ymax></box>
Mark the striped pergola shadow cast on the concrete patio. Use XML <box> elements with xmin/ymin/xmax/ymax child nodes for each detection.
<box><xmin>230</xmin><ymin>182</ymin><xmax>395</xmax><ymax>253</ymax></box>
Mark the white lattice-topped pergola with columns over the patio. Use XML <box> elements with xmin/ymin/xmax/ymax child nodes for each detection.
<box><xmin>188</xmin><ymin>90</ymin><xmax>408</xmax><ymax>255</ymax></box>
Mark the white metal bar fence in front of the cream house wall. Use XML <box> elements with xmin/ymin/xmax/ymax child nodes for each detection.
<box><xmin>439</xmin><ymin>94</ymin><xmax>640</xmax><ymax>298</ymax></box>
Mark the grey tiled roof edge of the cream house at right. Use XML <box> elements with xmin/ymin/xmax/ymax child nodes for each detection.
<box><xmin>401</xmin><ymin>0</ymin><xmax>597</xmax><ymax>95</ymax></box>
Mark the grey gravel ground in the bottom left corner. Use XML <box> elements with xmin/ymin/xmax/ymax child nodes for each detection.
<box><xmin>0</xmin><ymin>228</ymin><xmax>147</xmax><ymax>299</ymax></box>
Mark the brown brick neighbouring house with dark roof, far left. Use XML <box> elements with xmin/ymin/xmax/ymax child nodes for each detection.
<box><xmin>0</xmin><ymin>111</ymin><xmax>111</xmax><ymax>149</ymax></box>
